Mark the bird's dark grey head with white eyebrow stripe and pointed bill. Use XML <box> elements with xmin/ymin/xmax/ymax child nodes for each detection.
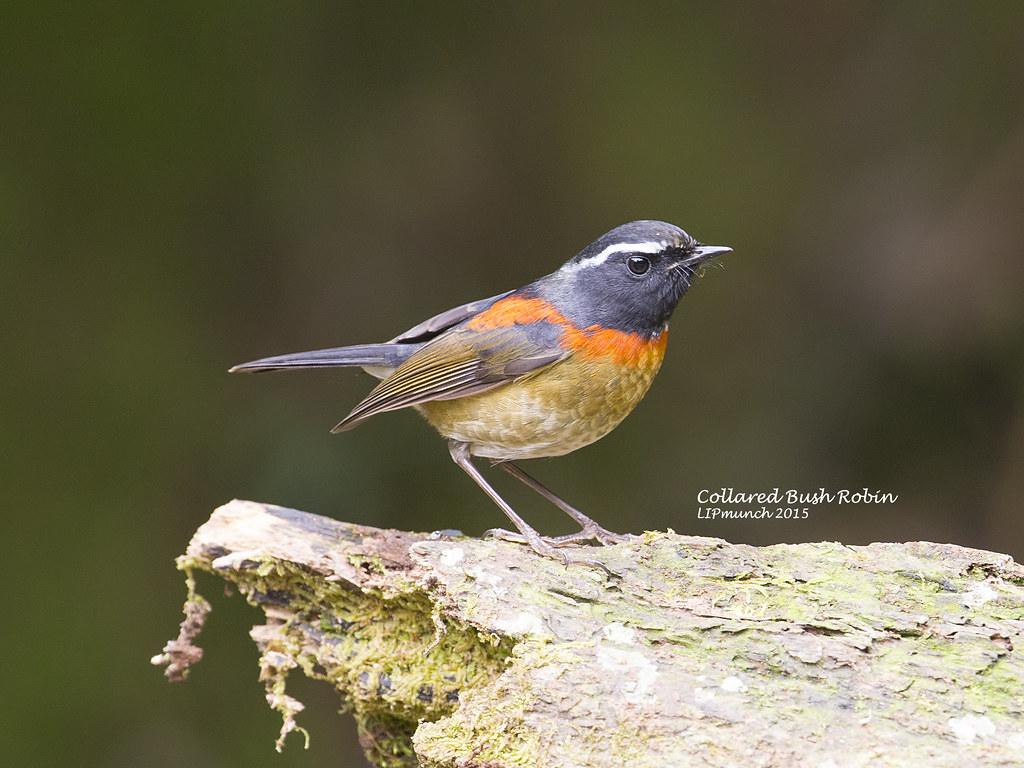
<box><xmin>536</xmin><ymin>220</ymin><xmax>732</xmax><ymax>334</ymax></box>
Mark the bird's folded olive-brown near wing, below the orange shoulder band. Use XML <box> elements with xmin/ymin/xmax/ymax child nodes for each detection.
<box><xmin>331</xmin><ymin>321</ymin><xmax>567</xmax><ymax>432</ymax></box>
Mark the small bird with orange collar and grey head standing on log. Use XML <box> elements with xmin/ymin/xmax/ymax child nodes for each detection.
<box><xmin>230</xmin><ymin>220</ymin><xmax>732</xmax><ymax>563</ymax></box>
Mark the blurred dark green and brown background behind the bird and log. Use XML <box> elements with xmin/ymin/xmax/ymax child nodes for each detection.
<box><xmin>0</xmin><ymin>0</ymin><xmax>1024</xmax><ymax>767</ymax></box>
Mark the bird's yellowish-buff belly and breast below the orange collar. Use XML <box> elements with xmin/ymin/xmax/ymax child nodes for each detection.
<box><xmin>417</xmin><ymin>355</ymin><xmax>662</xmax><ymax>460</ymax></box>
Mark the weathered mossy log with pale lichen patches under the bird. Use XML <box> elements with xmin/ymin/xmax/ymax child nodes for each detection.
<box><xmin>154</xmin><ymin>501</ymin><xmax>1024</xmax><ymax>768</ymax></box>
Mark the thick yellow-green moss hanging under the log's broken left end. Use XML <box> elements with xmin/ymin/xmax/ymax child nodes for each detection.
<box><xmin>179</xmin><ymin>558</ymin><xmax>512</xmax><ymax>768</ymax></box>
